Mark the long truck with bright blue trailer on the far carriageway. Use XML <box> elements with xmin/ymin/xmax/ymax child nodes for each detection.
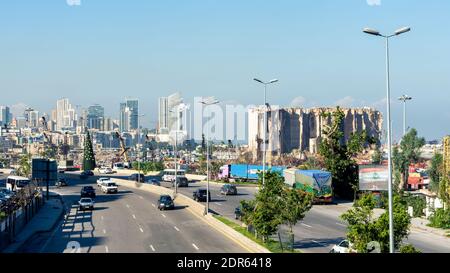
<box><xmin>218</xmin><ymin>164</ymin><xmax>286</xmax><ymax>181</ymax></box>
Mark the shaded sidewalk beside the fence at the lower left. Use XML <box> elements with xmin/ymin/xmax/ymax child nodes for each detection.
<box><xmin>3</xmin><ymin>194</ymin><xmax>64</xmax><ymax>253</ymax></box>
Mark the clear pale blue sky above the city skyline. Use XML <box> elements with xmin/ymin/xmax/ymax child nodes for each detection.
<box><xmin>0</xmin><ymin>0</ymin><xmax>450</xmax><ymax>139</ymax></box>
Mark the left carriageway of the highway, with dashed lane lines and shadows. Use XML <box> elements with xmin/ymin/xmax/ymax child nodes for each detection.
<box><xmin>21</xmin><ymin>174</ymin><xmax>246</xmax><ymax>253</ymax></box>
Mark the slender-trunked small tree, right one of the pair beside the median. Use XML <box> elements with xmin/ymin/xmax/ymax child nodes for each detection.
<box><xmin>281</xmin><ymin>186</ymin><xmax>314</xmax><ymax>248</ymax></box>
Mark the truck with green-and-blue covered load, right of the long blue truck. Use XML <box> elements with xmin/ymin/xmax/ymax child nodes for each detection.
<box><xmin>283</xmin><ymin>169</ymin><xmax>333</xmax><ymax>203</ymax></box>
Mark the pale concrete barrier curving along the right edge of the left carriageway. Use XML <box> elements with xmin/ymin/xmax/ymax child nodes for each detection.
<box><xmin>112</xmin><ymin>179</ymin><xmax>270</xmax><ymax>253</ymax></box>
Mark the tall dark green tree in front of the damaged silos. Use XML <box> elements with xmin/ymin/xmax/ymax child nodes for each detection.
<box><xmin>319</xmin><ymin>107</ymin><xmax>367</xmax><ymax>199</ymax></box>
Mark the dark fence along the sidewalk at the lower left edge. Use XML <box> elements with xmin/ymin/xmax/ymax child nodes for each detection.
<box><xmin>0</xmin><ymin>187</ymin><xmax>44</xmax><ymax>252</ymax></box>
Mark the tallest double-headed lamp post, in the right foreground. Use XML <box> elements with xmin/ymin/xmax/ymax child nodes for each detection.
<box><xmin>363</xmin><ymin>27</ymin><xmax>411</xmax><ymax>253</ymax></box>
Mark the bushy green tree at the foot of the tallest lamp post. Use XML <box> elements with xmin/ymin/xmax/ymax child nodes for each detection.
<box><xmin>341</xmin><ymin>194</ymin><xmax>411</xmax><ymax>253</ymax></box>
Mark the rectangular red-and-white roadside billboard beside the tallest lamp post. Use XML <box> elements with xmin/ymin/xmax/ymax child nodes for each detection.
<box><xmin>359</xmin><ymin>165</ymin><xmax>389</xmax><ymax>191</ymax></box>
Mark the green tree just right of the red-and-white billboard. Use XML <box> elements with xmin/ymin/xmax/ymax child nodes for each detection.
<box><xmin>392</xmin><ymin>128</ymin><xmax>425</xmax><ymax>189</ymax></box>
